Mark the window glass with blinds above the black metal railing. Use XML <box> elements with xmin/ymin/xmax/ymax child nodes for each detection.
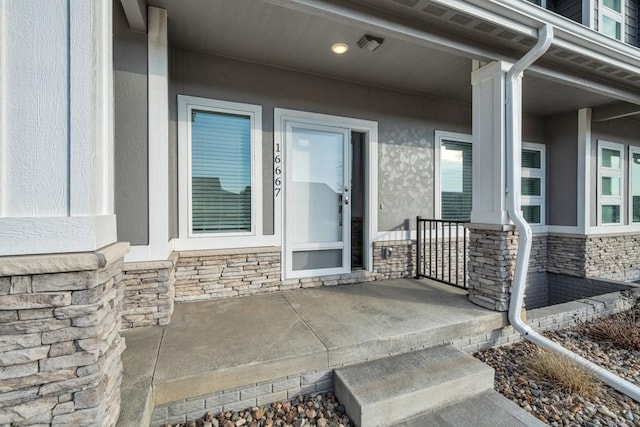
<box><xmin>440</xmin><ymin>141</ymin><xmax>473</xmax><ymax>221</ymax></box>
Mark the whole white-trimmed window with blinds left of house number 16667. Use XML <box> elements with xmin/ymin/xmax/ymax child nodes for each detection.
<box><xmin>178</xmin><ymin>95</ymin><xmax>262</xmax><ymax>237</ymax></box>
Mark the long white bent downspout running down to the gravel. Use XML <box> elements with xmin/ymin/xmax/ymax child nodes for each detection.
<box><xmin>505</xmin><ymin>24</ymin><xmax>640</xmax><ymax>402</ymax></box>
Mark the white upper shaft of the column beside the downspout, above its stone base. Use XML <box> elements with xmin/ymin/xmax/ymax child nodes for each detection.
<box><xmin>471</xmin><ymin>61</ymin><xmax>511</xmax><ymax>224</ymax></box>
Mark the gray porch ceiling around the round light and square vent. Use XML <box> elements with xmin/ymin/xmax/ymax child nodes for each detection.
<box><xmin>142</xmin><ymin>0</ymin><xmax>614</xmax><ymax>115</ymax></box>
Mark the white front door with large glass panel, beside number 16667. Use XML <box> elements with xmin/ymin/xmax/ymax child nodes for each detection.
<box><xmin>284</xmin><ymin>122</ymin><xmax>351</xmax><ymax>278</ymax></box>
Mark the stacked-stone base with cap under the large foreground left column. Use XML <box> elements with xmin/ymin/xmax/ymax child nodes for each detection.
<box><xmin>0</xmin><ymin>243</ymin><xmax>129</xmax><ymax>427</ymax></box>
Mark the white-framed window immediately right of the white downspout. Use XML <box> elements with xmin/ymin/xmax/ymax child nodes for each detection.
<box><xmin>520</xmin><ymin>143</ymin><xmax>546</xmax><ymax>225</ymax></box>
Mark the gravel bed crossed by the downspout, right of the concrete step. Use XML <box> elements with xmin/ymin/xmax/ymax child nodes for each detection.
<box><xmin>474</xmin><ymin>308</ymin><xmax>640</xmax><ymax>427</ymax></box>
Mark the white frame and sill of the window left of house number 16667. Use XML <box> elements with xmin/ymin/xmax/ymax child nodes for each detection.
<box><xmin>174</xmin><ymin>95</ymin><xmax>274</xmax><ymax>250</ymax></box>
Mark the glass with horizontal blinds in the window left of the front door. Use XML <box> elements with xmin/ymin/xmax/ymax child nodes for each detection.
<box><xmin>191</xmin><ymin>110</ymin><xmax>251</xmax><ymax>233</ymax></box>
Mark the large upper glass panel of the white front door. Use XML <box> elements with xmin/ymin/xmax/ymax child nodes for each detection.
<box><xmin>288</xmin><ymin>129</ymin><xmax>344</xmax><ymax>243</ymax></box>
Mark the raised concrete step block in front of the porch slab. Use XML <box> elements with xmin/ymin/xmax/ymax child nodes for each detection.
<box><xmin>334</xmin><ymin>346</ymin><xmax>494</xmax><ymax>427</ymax></box>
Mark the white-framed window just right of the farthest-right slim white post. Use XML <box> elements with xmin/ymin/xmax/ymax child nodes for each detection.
<box><xmin>597</xmin><ymin>141</ymin><xmax>624</xmax><ymax>225</ymax></box>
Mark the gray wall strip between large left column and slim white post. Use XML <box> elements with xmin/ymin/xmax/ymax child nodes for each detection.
<box><xmin>113</xmin><ymin>2</ymin><xmax>149</xmax><ymax>245</ymax></box>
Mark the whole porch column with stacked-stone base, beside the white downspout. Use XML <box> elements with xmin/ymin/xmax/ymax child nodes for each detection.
<box><xmin>467</xmin><ymin>61</ymin><xmax>517</xmax><ymax>311</ymax></box>
